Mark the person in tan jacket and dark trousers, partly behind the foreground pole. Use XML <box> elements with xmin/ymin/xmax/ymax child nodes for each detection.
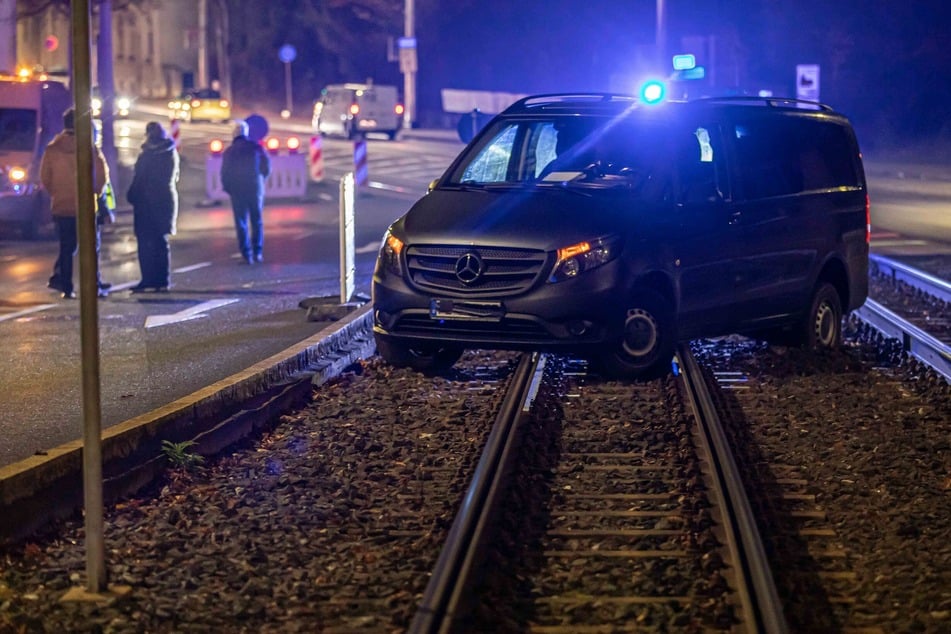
<box><xmin>40</xmin><ymin>108</ymin><xmax>109</xmax><ymax>299</ymax></box>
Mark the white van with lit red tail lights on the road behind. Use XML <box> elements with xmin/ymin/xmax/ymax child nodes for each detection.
<box><xmin>313</xmin><ymin>83</ymin><xmax>403</xmax><ymax>139</ymax></box>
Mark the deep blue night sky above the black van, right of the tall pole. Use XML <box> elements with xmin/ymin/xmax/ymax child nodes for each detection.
<box><xmin>408</xmin><ymin>0</ymin><xmax>951</xmax><ymax>151</ymax></box>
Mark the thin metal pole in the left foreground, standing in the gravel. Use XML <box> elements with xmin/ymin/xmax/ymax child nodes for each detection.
<box><xmin>72</xmin><ymin>0</ymin><xmax>106</xmax><ymax>593</ymax></box>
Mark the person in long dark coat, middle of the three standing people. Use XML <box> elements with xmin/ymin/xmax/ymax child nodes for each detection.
<box><xmin>126</xmin><ymin>121</ymin><xmax>179</xmax><ymax>293</ymax></box>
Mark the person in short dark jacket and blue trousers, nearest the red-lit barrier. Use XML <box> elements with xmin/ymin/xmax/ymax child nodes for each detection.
<box><xmin>221</xmin><ymin>119</ymin><xmax>271</xmax><ymax>264</ymax></box>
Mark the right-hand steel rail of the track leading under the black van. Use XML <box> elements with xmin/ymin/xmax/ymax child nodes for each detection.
<box><xmin>677</xmin><ymin>344</ymin><xmax>789</xmax><ymax>634</ymax></box>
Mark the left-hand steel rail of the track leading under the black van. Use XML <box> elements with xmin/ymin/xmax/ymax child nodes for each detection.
<box><xmin>407</xmin><ymin>353</ymin><xmax>546</xmax><ymax>634</ymax></box>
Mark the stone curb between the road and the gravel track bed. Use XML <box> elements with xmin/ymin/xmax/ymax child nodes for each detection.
<box><xmin>0</xmin><ymin>304</ymin><xmax>375</xmax><ymax>543</ymax></box>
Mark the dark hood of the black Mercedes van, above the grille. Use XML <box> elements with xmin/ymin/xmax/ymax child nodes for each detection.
<box><xmin>394</xmin><ymin>187</ymin><xmax>637</xmax><ymax>251</ymax></box>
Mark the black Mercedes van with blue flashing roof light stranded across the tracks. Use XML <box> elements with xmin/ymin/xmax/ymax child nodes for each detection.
<box><xmin>372</xmin><ymin>94</ymin><xmax>869</xmax><ymax>378</ymax></box>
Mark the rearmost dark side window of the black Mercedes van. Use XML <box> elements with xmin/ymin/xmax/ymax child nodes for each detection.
<box><xmin>733</xmin><ymin>118</ymin><xmax>859</xmax><ymax>200</ymax></box>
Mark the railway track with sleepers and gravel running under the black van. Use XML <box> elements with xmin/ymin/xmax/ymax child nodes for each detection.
<box><xmin>409</xmin><ymin>348</ymin><xmax>786</xmax><ymax>633</ymax></box>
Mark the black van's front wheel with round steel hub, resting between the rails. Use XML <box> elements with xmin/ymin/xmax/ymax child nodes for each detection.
<box><xmin>595</xmin><ymin>289</ymin><xmax>677</xmax><ymax>379</ymax></box>
